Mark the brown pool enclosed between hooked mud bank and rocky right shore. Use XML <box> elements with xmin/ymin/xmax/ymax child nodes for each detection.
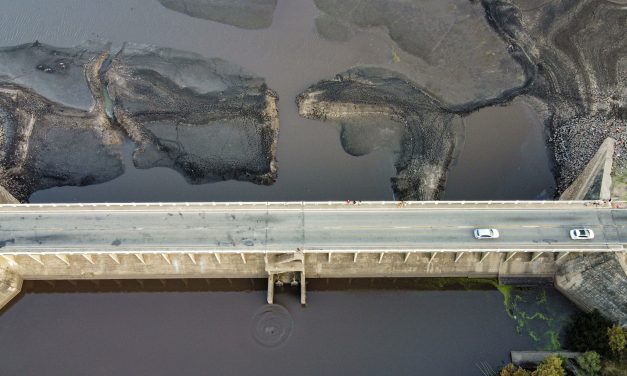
<box><xmin>443</xmin><ymin>100</ymin><xmax>555</xmax><ymax>200</ymax></box>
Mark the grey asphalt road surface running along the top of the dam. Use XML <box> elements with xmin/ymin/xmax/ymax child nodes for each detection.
<box><xmin>0</xmin><ymin>205</ymin><xmax>627</xmax><ymax>253</ymax></box>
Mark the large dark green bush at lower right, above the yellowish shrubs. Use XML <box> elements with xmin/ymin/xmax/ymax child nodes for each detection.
<box><xmin>566</xmin><ymin>310</ymin><xmax>612</xmax><ymax>355</ymax></box>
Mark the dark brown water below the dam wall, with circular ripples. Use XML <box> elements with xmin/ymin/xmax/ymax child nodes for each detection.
<box><xmin>0</xmin><ymin>284</ymin><xmax>572</xmax><ymax>376</ymax></box>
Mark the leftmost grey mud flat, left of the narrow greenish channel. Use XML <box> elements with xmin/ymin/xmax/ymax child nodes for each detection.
<box><xmin>0</xmin><ymin>43</ymin><xmax>124</xmax><ymax>201</ymax></box>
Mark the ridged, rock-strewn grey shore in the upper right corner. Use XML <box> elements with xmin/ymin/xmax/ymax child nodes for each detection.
<box><xmin>502</xmin><ymin>0</ymin><xmax>627</xmax><ymax>190</ymax></box>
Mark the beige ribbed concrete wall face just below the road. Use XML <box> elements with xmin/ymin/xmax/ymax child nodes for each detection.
<box><xmin>0</xmin><ymin>252</ymin><xmax>574</xmax><ymax>307</ymax></box>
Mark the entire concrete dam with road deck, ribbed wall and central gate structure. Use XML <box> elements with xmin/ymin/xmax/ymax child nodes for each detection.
<box><xmin>0</xmin><ymin>200</ymin><xmax>627</xmax><ymax>305</ymax></box>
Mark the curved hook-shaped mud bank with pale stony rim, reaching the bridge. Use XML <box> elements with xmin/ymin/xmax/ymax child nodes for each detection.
<box><xmin>296</xmin><ymin>68</ymin><xmax>457</xmax><ymax>200</ymax></box>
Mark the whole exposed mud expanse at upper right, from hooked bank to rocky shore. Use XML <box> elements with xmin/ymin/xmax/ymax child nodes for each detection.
<box><xmin>297</xmin><ymin>0</ymin><xmax>627</xmax><ymax>200</ymax></box>
